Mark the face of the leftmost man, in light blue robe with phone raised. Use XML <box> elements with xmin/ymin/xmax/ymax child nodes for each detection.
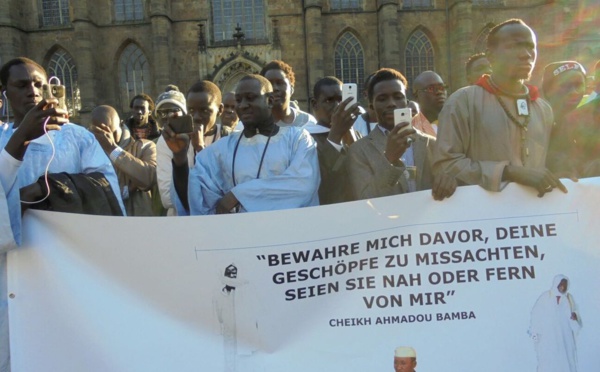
<box><xmin>6</xmin><ymin>64</ymin><xmax>47</xmax><ymax>118</ymax></box>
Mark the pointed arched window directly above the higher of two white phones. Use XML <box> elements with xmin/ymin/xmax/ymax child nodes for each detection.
<box><xmin>335</xmin><ymin>32</ymin><xmax>365</xmax><ymax>92</ymax></box>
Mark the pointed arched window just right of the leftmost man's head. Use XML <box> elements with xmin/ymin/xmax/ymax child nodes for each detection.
<box><xmin>47</xmin><ymin>49</ymin><xmax>81</xmax><ymax>116</ymax></box>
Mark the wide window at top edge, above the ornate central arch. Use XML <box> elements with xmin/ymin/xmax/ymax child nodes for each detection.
<box><xmin>211</xmin><ymin>0</ymin><xmax>267</xmax><ymax>43</ymax></box>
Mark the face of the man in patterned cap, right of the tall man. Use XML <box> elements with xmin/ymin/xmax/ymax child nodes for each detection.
<box><xmin>545</xmin><ymin>70</ymin><xmax>585</xmax><ymax>115</ymax></box>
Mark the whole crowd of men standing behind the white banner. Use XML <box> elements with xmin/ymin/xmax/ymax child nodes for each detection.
<box><xmin>0</xmin><ymin>19</ymin><xmax>600</xmax><ymax>370</ymax></box>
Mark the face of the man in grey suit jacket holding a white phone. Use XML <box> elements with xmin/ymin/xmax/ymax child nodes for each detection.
<box><xmin>369</xmin><ymin>79</ymin><xmax>407</xmax><ymax>130</ymax></box>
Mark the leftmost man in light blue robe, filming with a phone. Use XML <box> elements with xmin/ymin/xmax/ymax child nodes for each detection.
<box><xmin>0</xmin><ymin>57</ymin><xmax>125</xmax><ymax>371</ymax></box>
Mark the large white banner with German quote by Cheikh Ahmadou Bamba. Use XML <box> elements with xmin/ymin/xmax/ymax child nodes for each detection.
<box><xmin>9</xmin><ymin>179</ymin><xmax>600</xmax><ymax>372</ymax></box>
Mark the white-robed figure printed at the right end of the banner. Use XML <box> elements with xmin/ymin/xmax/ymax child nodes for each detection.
<box><xmin>529</xmin><ymin>275</ymin><xmax>581</xmax><ymax>372</ymax></box>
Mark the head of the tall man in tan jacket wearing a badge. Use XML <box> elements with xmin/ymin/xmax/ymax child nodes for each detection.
<box><xmin>488</xmin><ymin>23</ymin><xmax>537</xmax><ymax>80</ymax></box>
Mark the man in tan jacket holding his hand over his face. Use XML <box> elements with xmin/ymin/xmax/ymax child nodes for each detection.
<box><xmin>90</xmin><ymin>105</ymin><xmax>156</xmax><ymax>216</ymax></box>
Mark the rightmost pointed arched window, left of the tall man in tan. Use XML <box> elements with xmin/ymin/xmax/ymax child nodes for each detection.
<box><xmin>404</xmin><ymin>30</ymin><xmax>435</xmax><ymax>88</ymax></box>
